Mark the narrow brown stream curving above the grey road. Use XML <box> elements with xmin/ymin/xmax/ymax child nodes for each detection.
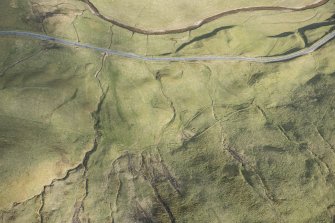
<box><xmin>82</xmin><ymin>0</ymin><xmax>329</xmax><ymax>35</ymax></box>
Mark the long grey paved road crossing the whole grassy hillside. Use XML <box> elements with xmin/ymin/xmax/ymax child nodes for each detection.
<box><xmin>0</xmin><ymin>30</ymin><xmax>335</xmax><ymax>63</ymax></box>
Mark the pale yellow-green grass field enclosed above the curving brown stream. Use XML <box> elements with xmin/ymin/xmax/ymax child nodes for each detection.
<box><xmin>91</xmin><ymin>0</ymin><xmax>320</xmax><ymax>30</ymax></box>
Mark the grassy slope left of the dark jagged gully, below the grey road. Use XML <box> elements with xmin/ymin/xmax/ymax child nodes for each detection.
<box><xmin>0</xmin><ymin>39</ymin><xmax>101</xmax><ymax>207</ymax></box>
